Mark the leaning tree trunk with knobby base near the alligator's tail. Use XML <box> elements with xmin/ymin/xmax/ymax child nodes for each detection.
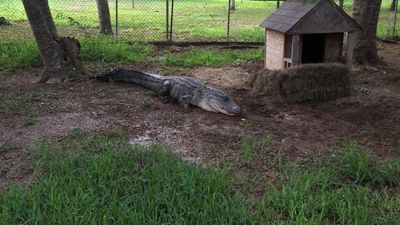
<box><xmin>22</xmin><ymin>0</ymin><xmax>82</xmax><ymax>83</ymax></box>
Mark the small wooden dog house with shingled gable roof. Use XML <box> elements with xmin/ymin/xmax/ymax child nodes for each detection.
<box><xmin>261</xmin><ymin>0</ymin><xmax>361</xmax><ymax>69</ymax></box>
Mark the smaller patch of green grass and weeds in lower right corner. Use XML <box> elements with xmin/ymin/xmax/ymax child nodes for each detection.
<box><xmin>258</xmin><ymin>164</ymin><xmax>400</xmax><ymax>224</ymax></box>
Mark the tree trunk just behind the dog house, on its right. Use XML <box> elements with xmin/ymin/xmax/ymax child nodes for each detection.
<box><xmin>353</xmin><ymin>0</ymin><xmax>382</xmax><ymax>65</ymax></box>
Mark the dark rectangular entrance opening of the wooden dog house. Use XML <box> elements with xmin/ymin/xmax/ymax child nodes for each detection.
<box><xmin>301</xmin><ymin>34</ymin><xmax>325</xmax><ymax>63</ymax></box>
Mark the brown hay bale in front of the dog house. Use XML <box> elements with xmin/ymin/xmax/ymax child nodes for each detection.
<box><xmin>253</xmin><ymin>63</ymin><xmax>350</xmax><ymax>103</ymax></box>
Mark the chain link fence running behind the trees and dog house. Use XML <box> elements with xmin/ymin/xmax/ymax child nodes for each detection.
<box><xmin>0</xmin><ymin>0</ymin><xmax>400</xmax><ymax>42</ymax></box>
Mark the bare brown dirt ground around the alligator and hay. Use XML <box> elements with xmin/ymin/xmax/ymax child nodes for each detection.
<box><xmin>0</xmin><ymin>43</ymin><xmax>400</xmax><ymax>186</ymax></box>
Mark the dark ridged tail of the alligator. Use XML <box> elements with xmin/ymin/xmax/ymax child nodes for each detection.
<box><xmin>96</xmin><ymin>69</ymin><xmax>165</xmax><ymax>92</ymax></box>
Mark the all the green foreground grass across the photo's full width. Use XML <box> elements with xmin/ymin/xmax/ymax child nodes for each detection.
<box><xmin>0</xmin><ymin>130</ymin><xmax>400</xmax><ymax>225</ymax></box>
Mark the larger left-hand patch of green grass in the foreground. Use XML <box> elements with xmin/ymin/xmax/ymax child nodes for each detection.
<box><xmin>0</xmin><ymin>132</ymin><xmax>252</xmax><ymax>225</ymax></box>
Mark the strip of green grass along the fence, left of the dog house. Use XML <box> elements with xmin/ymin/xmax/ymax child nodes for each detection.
<box><xmin>0</xmin><ymin>36</ymin><xmax>263</xmax><ymax>71</ymax></box>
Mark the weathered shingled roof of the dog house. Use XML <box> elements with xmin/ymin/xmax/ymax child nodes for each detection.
<box><xmin>261</xmin><ymin>0</ymin><xmax>361</xmax><ymax>34</ymax></box>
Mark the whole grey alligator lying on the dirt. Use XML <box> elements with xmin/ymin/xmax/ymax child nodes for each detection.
<box><xmin>96</xmin><ymin>68</ymin><xmax>241</xmax><ymax>116</ymax></box>
